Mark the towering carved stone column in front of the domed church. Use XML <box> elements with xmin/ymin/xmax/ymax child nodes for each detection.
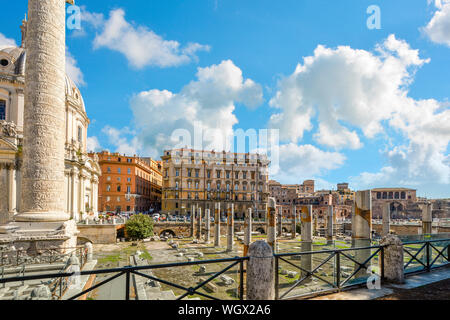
<box><xmin>15</xmin><ymin>0</ymin><xmax>70</xmax><ymax>222</ymax></box>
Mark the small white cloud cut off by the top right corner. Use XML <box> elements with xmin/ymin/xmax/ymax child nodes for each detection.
<box><xmin>422</xmin><ymin>0</ymin><xmax>450</xmax><ymax>47</ymax></box>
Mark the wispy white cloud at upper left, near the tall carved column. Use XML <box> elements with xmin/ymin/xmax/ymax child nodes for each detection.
<box><xmin>92</xmin><ymin>9</ymin><xmax>210</xmax><ymax>69</ymax></box>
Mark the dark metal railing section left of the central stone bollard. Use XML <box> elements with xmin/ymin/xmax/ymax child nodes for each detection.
<box><xmin>0</xmin><ymin>257</ymin><xmax>248</xmax><ymax>300</ymax></box>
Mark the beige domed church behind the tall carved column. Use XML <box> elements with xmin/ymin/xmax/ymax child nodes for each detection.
<box><xmin>0</xmin><ymin>26</ymin><xmax>101</xmax><ymax>224</ymax></box>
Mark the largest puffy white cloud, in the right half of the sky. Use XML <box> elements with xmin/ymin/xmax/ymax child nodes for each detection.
<box><xmin>270</xmin><ymin>35</ymin><xmax>428</xmax><ymax>149</ymax></box>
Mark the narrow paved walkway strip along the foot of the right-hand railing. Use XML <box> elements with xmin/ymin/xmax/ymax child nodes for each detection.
<box><xmin>310</xmin><ymin>267</ymin><xmax>450</xmax><ymax>300</ymax></box>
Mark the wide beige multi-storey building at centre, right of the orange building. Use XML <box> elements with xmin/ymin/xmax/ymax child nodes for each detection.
<box><xmin>161</xmin><ymin>149</ymin><xmax>270</xmax><ymax>217</ymax></box>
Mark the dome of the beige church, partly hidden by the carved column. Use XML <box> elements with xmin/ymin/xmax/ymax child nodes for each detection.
<box><xmin>0</xmin><ymin>47</ymin><xmax>86</xmax><ymax>113</ymax></box>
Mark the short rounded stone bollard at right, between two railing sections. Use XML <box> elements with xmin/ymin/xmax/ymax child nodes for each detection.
<box><xmin>380</xmin><ymin>234</ymin><xmax>405</xmax><ymax>283</ymax></box>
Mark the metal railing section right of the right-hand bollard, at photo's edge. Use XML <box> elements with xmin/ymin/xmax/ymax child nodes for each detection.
<box><xmin>403</xmin><ymin>239</ymin><xmax>450</xmax><ymax>274</ymax></box>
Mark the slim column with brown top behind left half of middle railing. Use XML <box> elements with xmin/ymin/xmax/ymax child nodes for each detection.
<box><xmin>300</xmin><ymin>205</ymin><xmax>313</xmax><ymax>283</ymax></box>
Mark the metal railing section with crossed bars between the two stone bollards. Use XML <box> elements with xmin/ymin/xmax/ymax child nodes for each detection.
<box><xmin>274</xmin><ymin>246</ymin><xmax>384</xmax><ymax>300</ymax></box>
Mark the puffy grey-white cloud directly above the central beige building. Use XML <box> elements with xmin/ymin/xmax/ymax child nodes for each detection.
<box><xmin>125</xmin><ymin>60</ymin><xmax>263</xmax><ymax>156</ymax></box>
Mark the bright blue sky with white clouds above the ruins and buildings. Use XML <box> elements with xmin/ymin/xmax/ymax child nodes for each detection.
<box><xmin>0</xmin><ymin>0</ymin><xmax>450</xmax><ymax>197</ymax></box>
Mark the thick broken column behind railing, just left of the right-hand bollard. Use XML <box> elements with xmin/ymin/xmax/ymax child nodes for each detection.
<box><xmin>352</xmin><ymin>190</ymin><xmax>372</xmax><ymax>278</ymax></box>
